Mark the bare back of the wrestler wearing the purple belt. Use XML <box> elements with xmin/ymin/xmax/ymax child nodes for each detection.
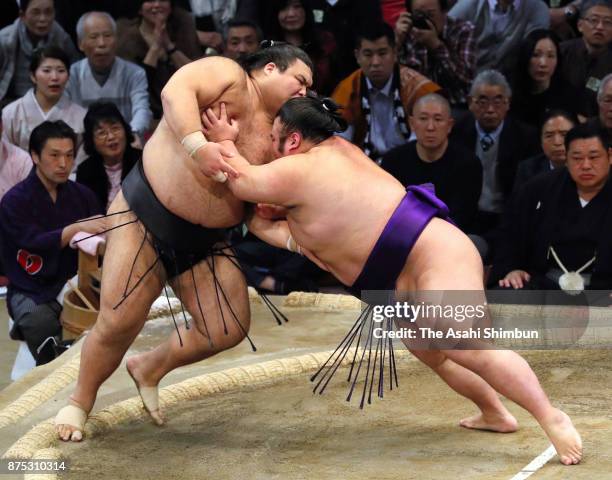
<box><xmin>288</xmin><ymin>137</ymin><xmax>405</xmax><ymax>285</ymax></box>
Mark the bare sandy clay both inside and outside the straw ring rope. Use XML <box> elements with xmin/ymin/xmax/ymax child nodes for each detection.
<box><xmin>0</xmin><ymin>298</ymin><xmax>612</xmax><ymax>480</ymax></box>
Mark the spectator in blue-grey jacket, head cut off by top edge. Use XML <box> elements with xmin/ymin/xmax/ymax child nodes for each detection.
<box><xmin>448</xmin><ymin>0</ymin><xmax>550</xmax><ymax>74</ymax></box>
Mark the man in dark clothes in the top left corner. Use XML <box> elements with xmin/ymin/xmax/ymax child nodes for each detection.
<box><xmin>0</xmin><ymin>0</ymin><xmax>79</xmax><ymax>104</ymax></box>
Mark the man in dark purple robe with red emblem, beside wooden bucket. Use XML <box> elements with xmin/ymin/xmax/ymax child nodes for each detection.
<box><xmin>0</xmin><ymin>120</ymin><xmax>106</xmax><ymax>365</ymax></box>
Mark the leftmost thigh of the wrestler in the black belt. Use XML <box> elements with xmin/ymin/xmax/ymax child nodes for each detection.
<box><xmin>98</xmin><ymin>192</ymin><xmax>165</xmax><ymax>333</ymax></box>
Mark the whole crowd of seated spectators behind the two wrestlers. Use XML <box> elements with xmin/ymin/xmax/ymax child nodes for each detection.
<box><xmin>0</xmin><ymin>0</ymin><xmax>612</xmax><ymax>364</ymax></box>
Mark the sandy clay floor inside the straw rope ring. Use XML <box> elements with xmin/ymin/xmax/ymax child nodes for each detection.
<box><xmin>60</xmin><ymin>350</ymin><xmax>612</xmax><ymax>480</ymax></box>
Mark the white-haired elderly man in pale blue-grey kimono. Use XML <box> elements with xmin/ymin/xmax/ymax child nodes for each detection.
<box><xmin>67</xmin><ymin>12</ymin><xmax>152</xmax><ymax>140</ymax></box>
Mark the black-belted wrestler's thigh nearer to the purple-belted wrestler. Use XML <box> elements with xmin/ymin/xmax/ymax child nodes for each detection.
<box><xmin>170</xmin><ymin>256</ymin><xmax>250</xmax><ymax>350</ymax></box>
